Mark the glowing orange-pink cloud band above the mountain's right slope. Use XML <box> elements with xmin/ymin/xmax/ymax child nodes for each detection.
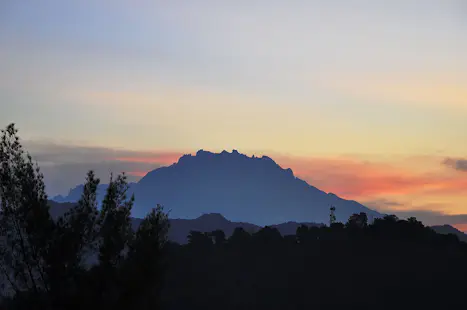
<box><xmin>277</xmin><ymin>157</ymin><xmax>467</xmax><ymax>199</ymax></box>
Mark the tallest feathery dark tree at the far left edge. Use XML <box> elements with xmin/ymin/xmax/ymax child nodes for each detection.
<box><xmin>0</xmin><ymin>124</ymin><xmax>55</xmax><ymax>304</ymax></box>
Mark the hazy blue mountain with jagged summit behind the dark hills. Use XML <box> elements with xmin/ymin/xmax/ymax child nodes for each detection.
<box><xmin>54</xmin><ymin>150</ymin><xmax>381</xmax><ymax>225</ymax></box>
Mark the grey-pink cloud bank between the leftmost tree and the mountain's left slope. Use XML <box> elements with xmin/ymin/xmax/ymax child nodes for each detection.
<box><xmin>24</xmin><ymin>141</ymin><xmax>183</xmax><ymax>195</ymax></box>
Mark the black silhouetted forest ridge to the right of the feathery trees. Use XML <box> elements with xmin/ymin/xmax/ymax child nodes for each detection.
<box><xmin>163</xmin><ymin>214</ymin><xmax>467</xmax><ymax>309</ymax></box>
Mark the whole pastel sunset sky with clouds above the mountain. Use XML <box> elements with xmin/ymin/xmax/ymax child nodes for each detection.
<box><xmin>0</xmin><ymin>0</ymin><xmax>467</xmax><ymax>231</ymax></box>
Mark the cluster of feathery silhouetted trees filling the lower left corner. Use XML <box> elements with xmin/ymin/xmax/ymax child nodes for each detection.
<box><xmin>0</xmin><ymin>124</ymin><xmax>168</xmax><ymax>309</ymax></box>
